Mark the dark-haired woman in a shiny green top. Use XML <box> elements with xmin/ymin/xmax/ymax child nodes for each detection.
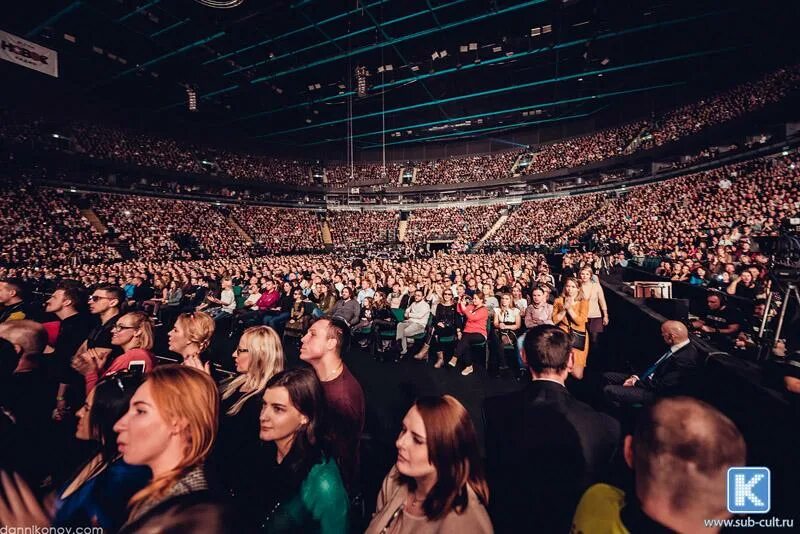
<box><xmin>259</xmin><ymin>368</ymin><xmax>350</xmax><ymax>534</ymax></box>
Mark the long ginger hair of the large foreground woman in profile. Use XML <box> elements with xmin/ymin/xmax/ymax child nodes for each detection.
<box><xmin>129</xmin><ymin>365</ymin><xmax>219</xmax><ymax>509</ymax></box>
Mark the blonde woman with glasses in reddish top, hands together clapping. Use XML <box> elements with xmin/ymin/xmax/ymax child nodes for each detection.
<box><xmin>78</xmin><ymin>312</ymin><xmax>153</xmax><ymax>395</ymax></box>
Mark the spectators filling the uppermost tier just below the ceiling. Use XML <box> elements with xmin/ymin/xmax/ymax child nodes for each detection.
<box><xmin>0</xmin><ymin>65</ymin><xmax>800</xmax><ymax>191</ymax></box>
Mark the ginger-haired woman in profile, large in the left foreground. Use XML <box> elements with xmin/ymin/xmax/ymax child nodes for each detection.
<box><xmin>114</xmin><ymin>365</ymin><xmax>232</xmax><ymax>534</ymax></box>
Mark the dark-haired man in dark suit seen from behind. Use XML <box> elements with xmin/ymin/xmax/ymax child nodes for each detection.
<box><xmin>484</xmin><ymin>325</ymin><xmax>620</xmax><ymax>532</ymax></box>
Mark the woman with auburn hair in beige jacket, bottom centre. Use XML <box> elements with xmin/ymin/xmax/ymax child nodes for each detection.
<box><xmin>366</xmin><ymin>395</ymin><xmax>493</xmax><ymax>534</ymax></box>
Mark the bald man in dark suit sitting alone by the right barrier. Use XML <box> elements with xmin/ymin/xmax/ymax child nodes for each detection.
<box><xmin>603</xmin><ymin>321</ymin><xmax>700</xmax><ymax>405</ymax></box>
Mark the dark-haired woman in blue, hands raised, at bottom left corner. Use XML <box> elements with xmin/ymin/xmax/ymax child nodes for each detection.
<box><xmin>0</xmin><ymin>371</ymin><xmax>150</xmax><ymax>532</ymax></box>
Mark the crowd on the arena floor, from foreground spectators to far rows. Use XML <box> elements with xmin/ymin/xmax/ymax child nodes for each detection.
<box><xmin>0</xmin><ymin>233</ymin><xmax>796</xmax><ymax>533</ymax></box>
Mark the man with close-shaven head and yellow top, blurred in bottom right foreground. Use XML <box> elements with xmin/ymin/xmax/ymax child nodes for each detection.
<box><xmin>572</xmin><ymin>397</ymin><xmax>746</xmax><ymax>533</ymax></box>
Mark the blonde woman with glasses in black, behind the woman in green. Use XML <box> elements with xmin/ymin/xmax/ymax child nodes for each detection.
<box><xmin>211</xmin><ymin>326</ymin><xmax>285</xmax><ymax>514</ymax></box>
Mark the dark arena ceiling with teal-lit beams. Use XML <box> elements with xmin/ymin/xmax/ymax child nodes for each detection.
<box><xmin>0</xmin><ymin>0</ymin><xmax>800</xmax><ymax>153</ymax></box>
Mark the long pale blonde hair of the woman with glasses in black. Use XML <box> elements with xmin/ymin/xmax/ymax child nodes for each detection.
<box><xmin>222</xmin><ymin>326</ymin><xmax>284</xmax><ymax>415</ymax></box>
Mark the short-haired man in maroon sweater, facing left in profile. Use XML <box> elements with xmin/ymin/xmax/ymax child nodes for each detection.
<box><xmin>300</xmin><ymin>316</ymin><xmax>366</xmax><ymax>491</ymax></box>
